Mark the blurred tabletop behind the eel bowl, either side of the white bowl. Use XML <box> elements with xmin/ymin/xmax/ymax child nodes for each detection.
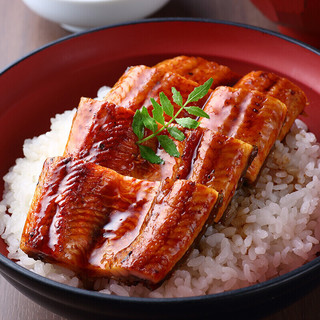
<box><xmin>0</xmin><ymin>0</ymin><xmax>277</xmax><ymax>70</ymax></box>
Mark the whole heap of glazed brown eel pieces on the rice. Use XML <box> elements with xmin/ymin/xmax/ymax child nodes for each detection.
<box><xmin>21</xmin><ymin>56</ymin><xmax>306</xmax><ymax>285</ymax></box>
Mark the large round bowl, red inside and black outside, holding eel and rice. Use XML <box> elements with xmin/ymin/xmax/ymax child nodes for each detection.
<box><xmin>0</xmin><ymin>19</ymin><xmax>320</xmax><ymax>319</ymax></box>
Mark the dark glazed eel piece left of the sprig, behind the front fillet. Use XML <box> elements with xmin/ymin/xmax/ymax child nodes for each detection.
<box><xmin>63</xmin><ymin>98</ymin><xmax>161</xmax><ymax>180</ymax></box>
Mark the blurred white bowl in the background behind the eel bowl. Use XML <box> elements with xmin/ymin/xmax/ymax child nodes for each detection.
<box><xmin>23</xmin><ymin>0</ymin><xmax>169</xmax><ymax>32</ymax></box>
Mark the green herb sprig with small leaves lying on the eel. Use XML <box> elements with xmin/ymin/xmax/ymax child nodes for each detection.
<box><xmin>132</xmin><ymin>79</ymin><xmax>213</xmax><ymax>164</ymax></box>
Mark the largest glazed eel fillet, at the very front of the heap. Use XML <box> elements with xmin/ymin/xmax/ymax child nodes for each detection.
<box><xmin>21</xmin><ymin>157</ymin><xmax>218</xmax><ymax>284</ymax></box>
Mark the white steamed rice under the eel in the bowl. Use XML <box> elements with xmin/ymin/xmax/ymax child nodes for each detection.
<box><xmin>0</xmin><ymin>89</ymin><xmax>320</xmax><ymax>298</ymax></box>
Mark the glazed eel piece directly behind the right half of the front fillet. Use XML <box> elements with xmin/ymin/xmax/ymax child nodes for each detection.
<box><xmin>187</xmin><ymin>127</ymin><xmax>257</xmax><ymax>222</ymax></box>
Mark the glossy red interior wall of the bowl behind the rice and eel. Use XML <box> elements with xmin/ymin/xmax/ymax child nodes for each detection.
<box><xmin>0</xmin><ymin>20</ymin><xmax>320</xmax><ymax>300</ymax></box>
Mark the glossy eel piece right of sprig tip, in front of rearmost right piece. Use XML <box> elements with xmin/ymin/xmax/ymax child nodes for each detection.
<box><xmin>200</xmin><ymin>87</ymin><xmax>287</xmax><ymax>183</ymax></box>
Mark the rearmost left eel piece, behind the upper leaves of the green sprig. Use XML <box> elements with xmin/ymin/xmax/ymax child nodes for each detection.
<box><xmin>104</xmin><ymin>56</ymin><xmax>240</xmax><ymax>111</ymax></box>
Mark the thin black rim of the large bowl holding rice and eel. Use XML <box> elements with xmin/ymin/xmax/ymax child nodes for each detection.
<box><xmin>0</xmin><ymin>18</ymin><xmax>320</xmax><ymax>304</ymax></box>
